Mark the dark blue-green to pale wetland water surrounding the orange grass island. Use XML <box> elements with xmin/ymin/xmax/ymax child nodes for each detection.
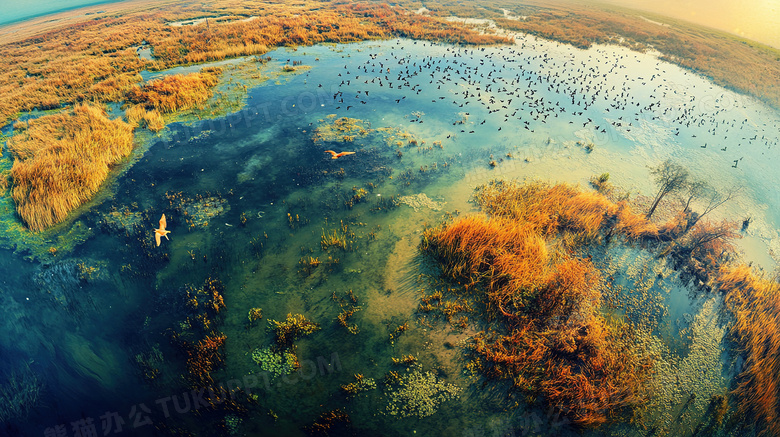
<box><xmin>0</xmin><ymin>36</ymin><xmax>780</xmax><ymax>435</ymax></box>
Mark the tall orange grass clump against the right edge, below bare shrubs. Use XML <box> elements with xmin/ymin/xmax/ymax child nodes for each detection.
<box><xmin>717</xmin><ymin>264</ymin><xmax>780</xmax><ymax>435</ymax></box>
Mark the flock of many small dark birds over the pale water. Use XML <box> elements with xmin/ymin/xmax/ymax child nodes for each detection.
<box><xmin>308</xmin><ymin>40</ymin><xmax>780</xmax><ymax>168</ymax></box>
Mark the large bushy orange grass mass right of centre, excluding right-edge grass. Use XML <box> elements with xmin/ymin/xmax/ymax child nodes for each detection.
<box><xmin>420</xmin><ymin>179</ymin><xmax>654</xmax><ymax>426</ymax></box>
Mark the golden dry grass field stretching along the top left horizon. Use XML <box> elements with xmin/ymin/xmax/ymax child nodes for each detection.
<box><xmin>0</xmin><ymin>0</ymin><xmax>506</xmax><ymax>124</ymax></box>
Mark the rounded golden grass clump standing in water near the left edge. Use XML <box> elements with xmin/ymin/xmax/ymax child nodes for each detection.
<box><xmin>8</xmin><ymin>105</ymin><xmax>133</xmax><ymax>231</ymax></box>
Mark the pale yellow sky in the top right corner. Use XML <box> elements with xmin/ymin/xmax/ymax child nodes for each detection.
<box><xmin>602</xmin><ymin>0</ymin><xmax>780</xmax><ymax>48</ymax></box>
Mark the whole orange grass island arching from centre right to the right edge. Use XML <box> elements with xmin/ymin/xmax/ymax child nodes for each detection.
<box><xmin>419</xmin><ymin>181</ymin><xmax>780</xmax><ymax>433</ymax></box>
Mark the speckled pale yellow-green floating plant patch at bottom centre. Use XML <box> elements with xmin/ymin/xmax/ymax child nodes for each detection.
<box><xmin>385</xmin><ymin>365</ymin><xmax>461</xmax><ymax>418</ymax></box>
